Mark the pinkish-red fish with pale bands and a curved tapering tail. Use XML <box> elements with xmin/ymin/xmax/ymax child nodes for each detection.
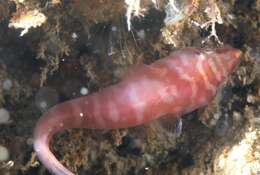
<box><xmin>34</xmin><ymin>48</ymin><xmax>241</xmax><ymax>175</ymax></box>
